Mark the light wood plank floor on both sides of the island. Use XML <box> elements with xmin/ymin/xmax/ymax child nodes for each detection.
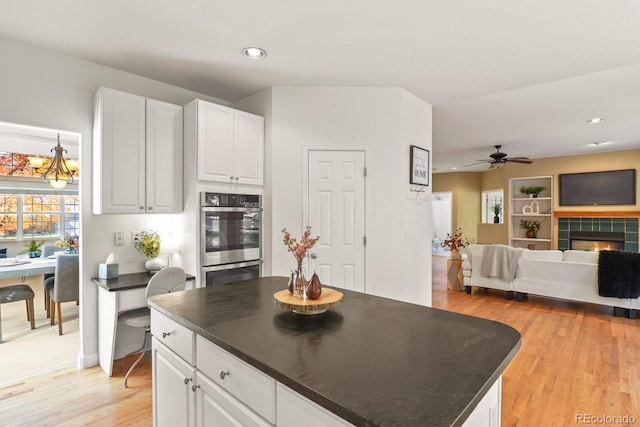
<box><xmin>0</xmin><ymin>257</ymin><xmax>640</xmax><ymax>427</ymax></box>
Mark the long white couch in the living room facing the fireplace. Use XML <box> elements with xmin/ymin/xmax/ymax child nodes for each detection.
<box><xmin>463</xmin><ymin>245</ymin><xmax>640</xmax><ymax>317</ymax></box>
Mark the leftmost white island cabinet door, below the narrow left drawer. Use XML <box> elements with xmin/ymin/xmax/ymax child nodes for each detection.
<box><xmin>151</xmin><ymin>338</ymin><xmax>196</xmax><ymax>427</ymax></box>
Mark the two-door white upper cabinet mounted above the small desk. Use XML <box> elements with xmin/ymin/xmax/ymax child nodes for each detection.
<box><xmin>93</xmin><ymin>88</ymin><xmax>183</xmax><ymax>214</ymax></box>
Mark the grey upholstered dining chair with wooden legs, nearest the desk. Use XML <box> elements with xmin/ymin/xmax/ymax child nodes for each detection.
<box><xmin>45</xmin><ymin>254</ymin><xmax>80</xmax><ymax>335</ymax></box>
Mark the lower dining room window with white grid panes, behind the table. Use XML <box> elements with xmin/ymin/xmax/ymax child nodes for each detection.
<box><xmin>0</xmin><ymin>194</ymin><xmax>80</xmax><ymax>240</ymax></box>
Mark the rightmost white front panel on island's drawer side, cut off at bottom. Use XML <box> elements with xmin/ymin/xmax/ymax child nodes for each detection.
<box><xmin>276</xmin><ymin>383</ymin><xmax>353</xmax><ymax>427</ymax></box>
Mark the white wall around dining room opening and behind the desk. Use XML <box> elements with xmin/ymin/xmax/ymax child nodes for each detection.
<box><xmin>0</xmin><ymin>39</ymin><xmax>230</xmax><ymax>367</ymax></box>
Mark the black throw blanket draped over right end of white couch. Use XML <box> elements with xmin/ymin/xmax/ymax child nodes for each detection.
<box><xmin>598</xmin><ymin>251</ymin><xmax>640</xmax><ymax>298</ymax></box>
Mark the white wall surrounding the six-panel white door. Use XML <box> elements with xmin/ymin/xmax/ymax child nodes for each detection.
<box><xmin>237</xmin><ymin>87</ymin><xmax>432</xmax><ymax>305</ymax></box>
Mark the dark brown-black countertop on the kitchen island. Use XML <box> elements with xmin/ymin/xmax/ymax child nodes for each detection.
<box><xmin>149</xmin><ymin>277</ymin><xmax>520</xmax><ymax>426</ymax></box>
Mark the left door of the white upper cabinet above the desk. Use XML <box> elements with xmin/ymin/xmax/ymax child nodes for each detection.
<box><xmin>93</xmin><ymin>88</ymin><xmax>145</xmax><ymax>213</ymax></box>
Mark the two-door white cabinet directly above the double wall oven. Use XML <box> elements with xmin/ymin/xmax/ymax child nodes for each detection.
<box><xmin>185</xmin><ymin>100</ymin><xmax>264</xmax><ymax>185</ymax></box>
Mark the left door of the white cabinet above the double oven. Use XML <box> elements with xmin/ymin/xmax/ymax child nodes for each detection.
<box><xmin>197</xmin><ymin>101</ymin><xmax>236</xmax><ymax>183</ymax></box>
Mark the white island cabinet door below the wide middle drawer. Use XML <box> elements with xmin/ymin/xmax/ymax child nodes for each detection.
<box><xmin>196</xmin><ymin>373</ymin><xmax>271</xmax><ymax>427</ymax></box>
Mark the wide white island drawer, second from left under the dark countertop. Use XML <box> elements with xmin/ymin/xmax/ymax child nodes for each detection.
<box><xmin>196</xmin><ymin>335</ymin><xmax>276</xmax><ymax>424</ymax></box>
